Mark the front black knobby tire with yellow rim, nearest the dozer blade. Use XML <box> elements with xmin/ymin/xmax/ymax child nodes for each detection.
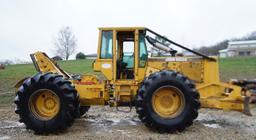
<box><xmin>135</xmin><ymin>71</ymin><xmax>200</xmax><ymax>133</ymax></box>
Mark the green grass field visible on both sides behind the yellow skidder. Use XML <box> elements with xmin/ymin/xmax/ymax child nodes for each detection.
<box><xmin>0</xmin><ymin>57</ymin><xmax>256</xmax><ymax>104</ymax></box>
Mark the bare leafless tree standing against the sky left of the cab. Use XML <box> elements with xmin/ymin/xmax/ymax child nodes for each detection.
<box><xmin>54</xmin><ymin>26</ymin><xmax>77</xmax><ymax>60</ymax></box>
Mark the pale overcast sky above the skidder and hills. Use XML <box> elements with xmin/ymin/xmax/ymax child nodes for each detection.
<box><xmin>0</xmin><ymin>0</ymin><xmax>256</xmax><ymax>60</ymax></box>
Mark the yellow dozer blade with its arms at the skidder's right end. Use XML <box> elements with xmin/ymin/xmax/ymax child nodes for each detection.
<box><xmin>198</xmin><ymin>83</ymin><xmax>256</xmax><ymax>116</ymax></box>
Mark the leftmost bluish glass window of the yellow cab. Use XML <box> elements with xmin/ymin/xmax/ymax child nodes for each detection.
<box><xmin>100</xmin><ymin>31</ymin><xmax>113</xmax><ymax>59</ymax></box>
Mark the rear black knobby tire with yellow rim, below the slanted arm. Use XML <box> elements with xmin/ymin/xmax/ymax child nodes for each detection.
<box><xmin>14</xmin><ymin>73</ymin><xmax>79</xmax><ymax>134</ymax></box>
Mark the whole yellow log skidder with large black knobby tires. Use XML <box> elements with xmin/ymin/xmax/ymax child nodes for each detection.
<box><xmin>15</xmin><ymin>27</ymin><xmax>256</xmax><ymax>133</ymax></box>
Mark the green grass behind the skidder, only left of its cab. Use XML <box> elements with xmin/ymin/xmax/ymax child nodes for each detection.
<box><xmin>0</xmin><ymin>60</ymin><xmax>93</xmax><ymax>104</ymax></box>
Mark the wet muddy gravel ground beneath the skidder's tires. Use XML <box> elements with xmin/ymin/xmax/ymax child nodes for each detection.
<box><xmin>0</xmin><ymin>105</ymin><xmax>256</xmax><ymax>140</ymax></box>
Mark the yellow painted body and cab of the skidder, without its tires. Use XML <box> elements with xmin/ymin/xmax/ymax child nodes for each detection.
<box><xmin>19</xmin><ymin>27</ymin><xmax>255</xmax><ymax>114</ymax></box>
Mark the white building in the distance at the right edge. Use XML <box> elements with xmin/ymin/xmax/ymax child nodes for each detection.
<box><xmin>219</xmin><ymin>40</ymin><xmax>256</xmax><ymax>57</ymax></box>
